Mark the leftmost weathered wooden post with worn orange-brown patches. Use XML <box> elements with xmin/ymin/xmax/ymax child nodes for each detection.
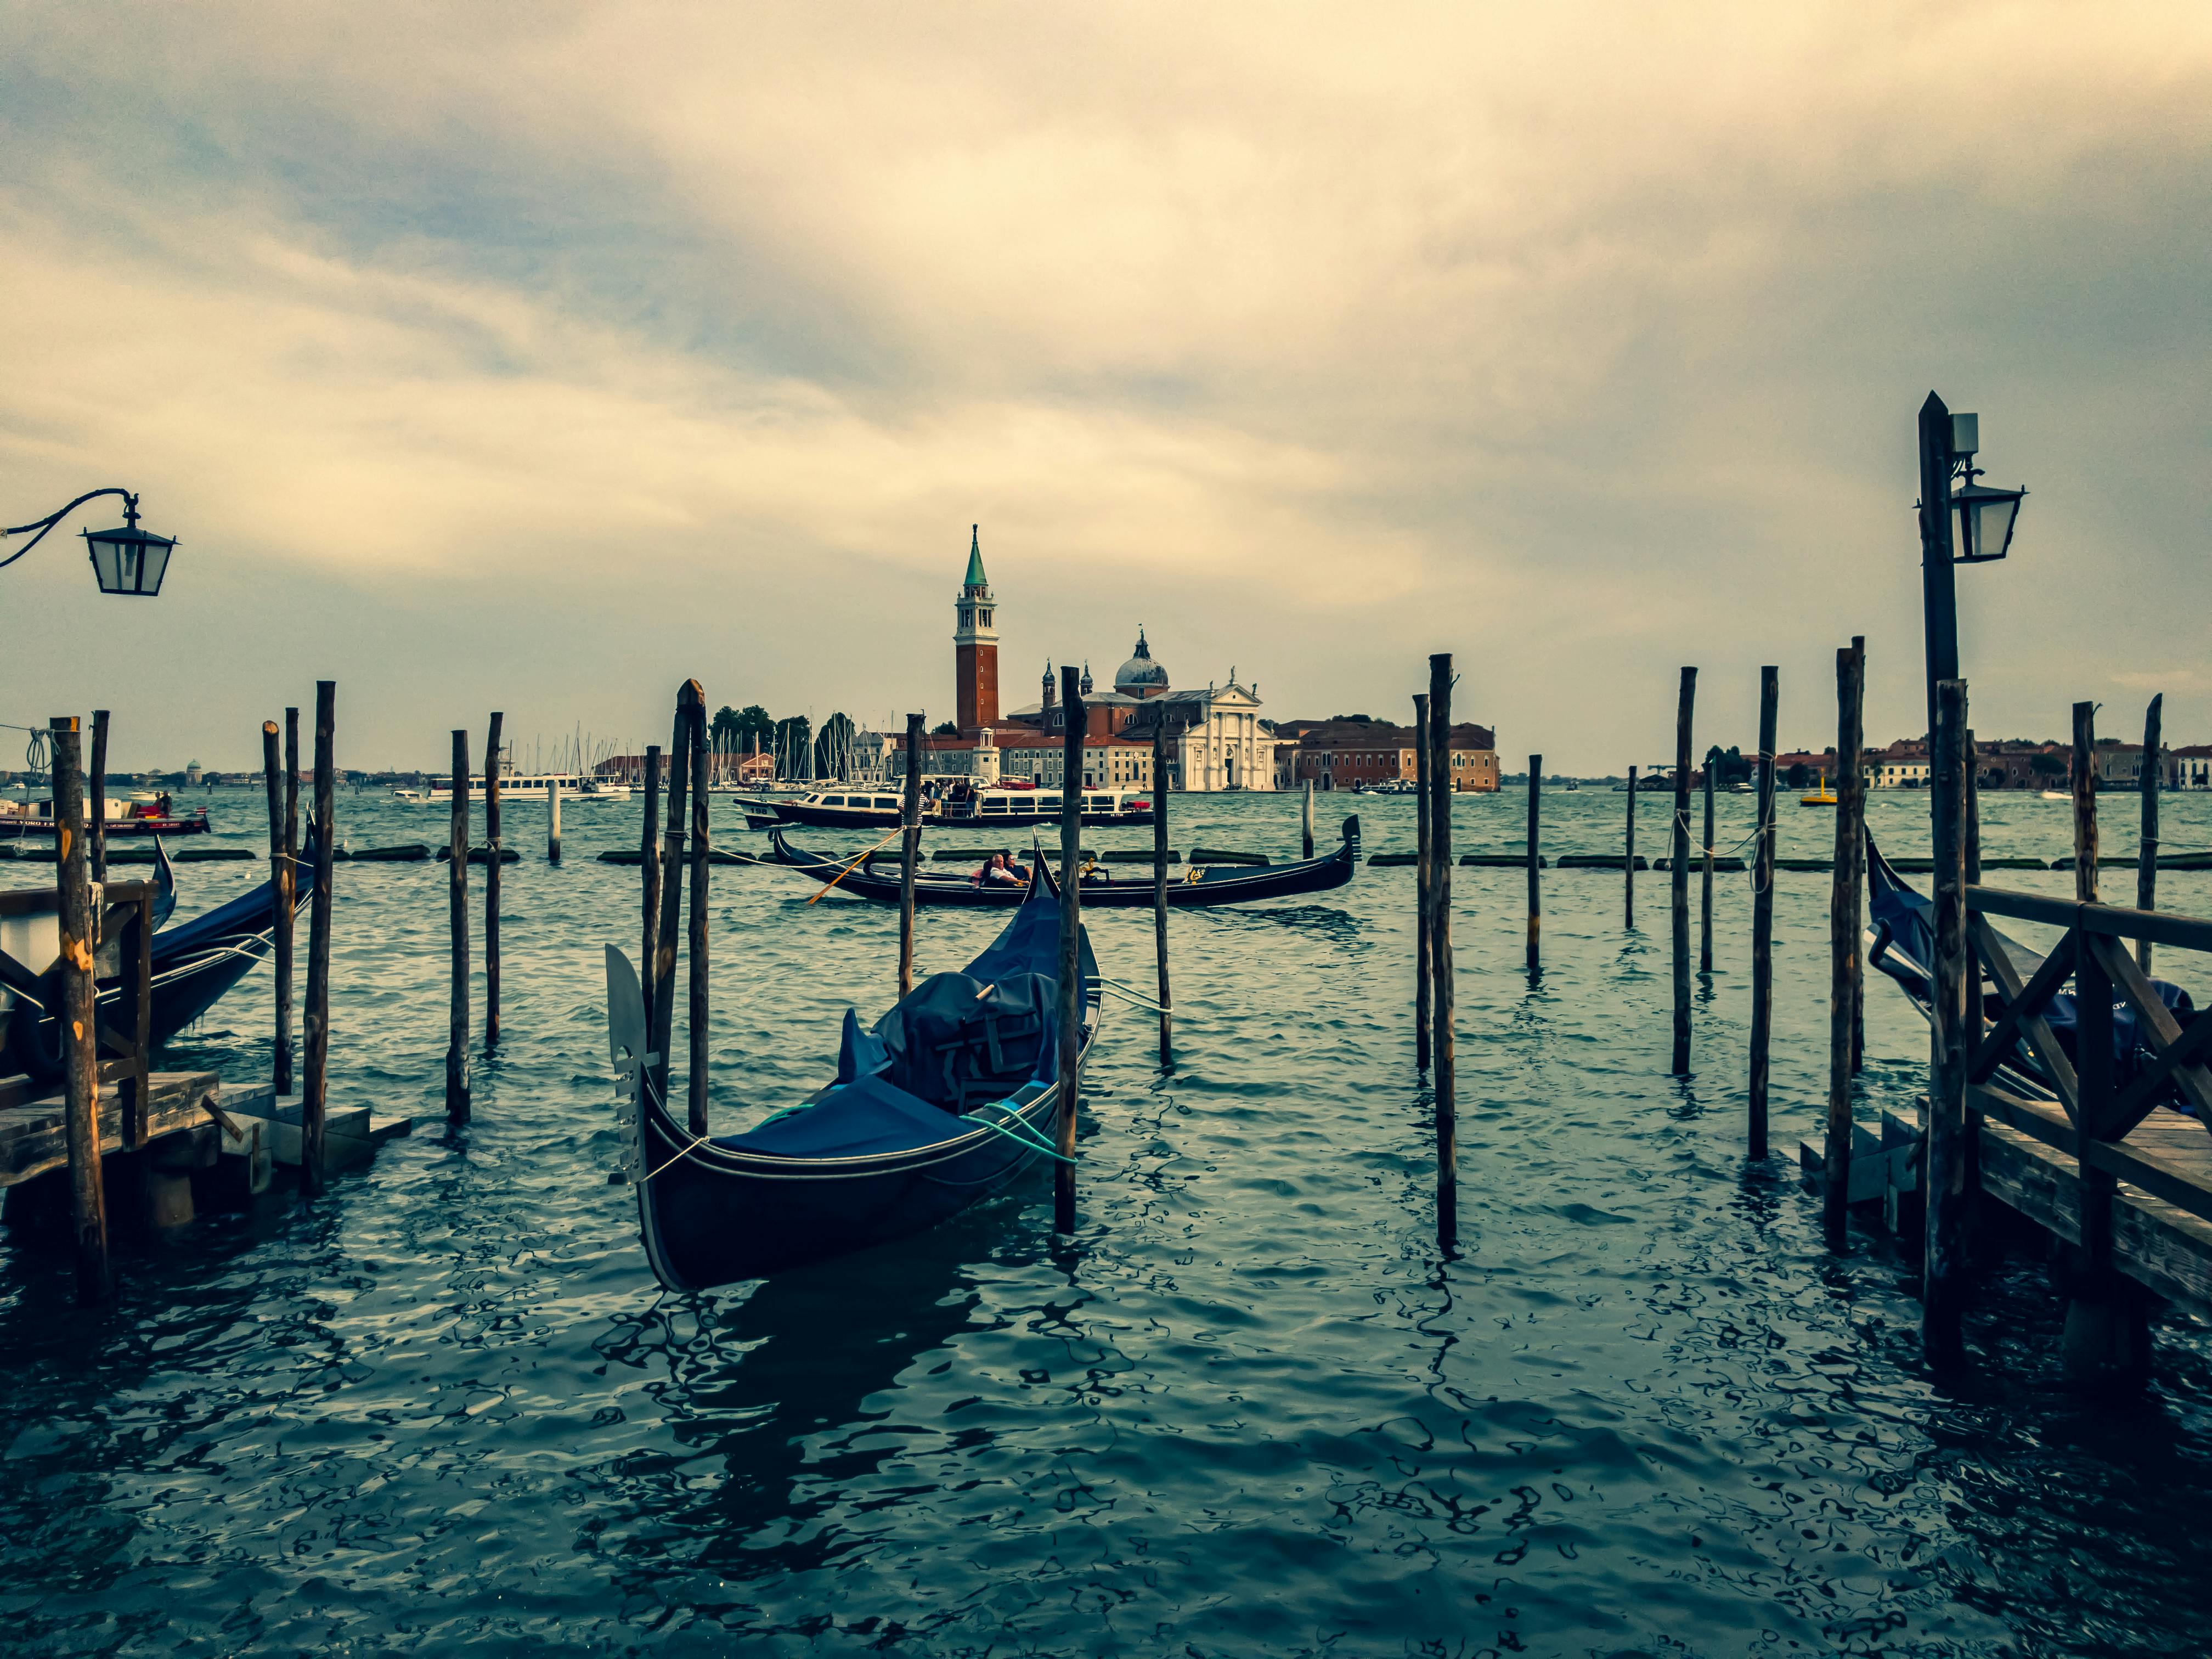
<box><xmin>49</xmin><ymin>714</ymin><xmax>115</xmax><ymax>1303</ymax></box>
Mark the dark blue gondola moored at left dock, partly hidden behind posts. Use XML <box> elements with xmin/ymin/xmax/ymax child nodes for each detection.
<box><xmin>0</xmin><ymin>832</ymin><xmax>314</xmax><ymax>1082</ymax></box>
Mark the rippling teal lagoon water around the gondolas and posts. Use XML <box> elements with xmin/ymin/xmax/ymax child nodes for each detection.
<box><xmin>0</xmin><ymin>789</ymin><xmax>2212</xmax><ymax>1657</ymax></box>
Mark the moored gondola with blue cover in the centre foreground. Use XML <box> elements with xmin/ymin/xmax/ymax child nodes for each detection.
<box><xmin>606</xmin><ymin>849</ymin><xmax>1104</xmax><ymax>1290</ymax></box>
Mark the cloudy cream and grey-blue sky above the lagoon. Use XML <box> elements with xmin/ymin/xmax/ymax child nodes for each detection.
<box><xmin>0</xmin><ymin>0</ymin><xmax>2212</xmax><ymax>774</ymax></box>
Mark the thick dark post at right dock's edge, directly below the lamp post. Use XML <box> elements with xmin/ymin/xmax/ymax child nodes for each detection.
<box><xmin>1920</xmin><ymin>679</ymin><xmax>1980</xmax><ymax>1367</ymax></box>
